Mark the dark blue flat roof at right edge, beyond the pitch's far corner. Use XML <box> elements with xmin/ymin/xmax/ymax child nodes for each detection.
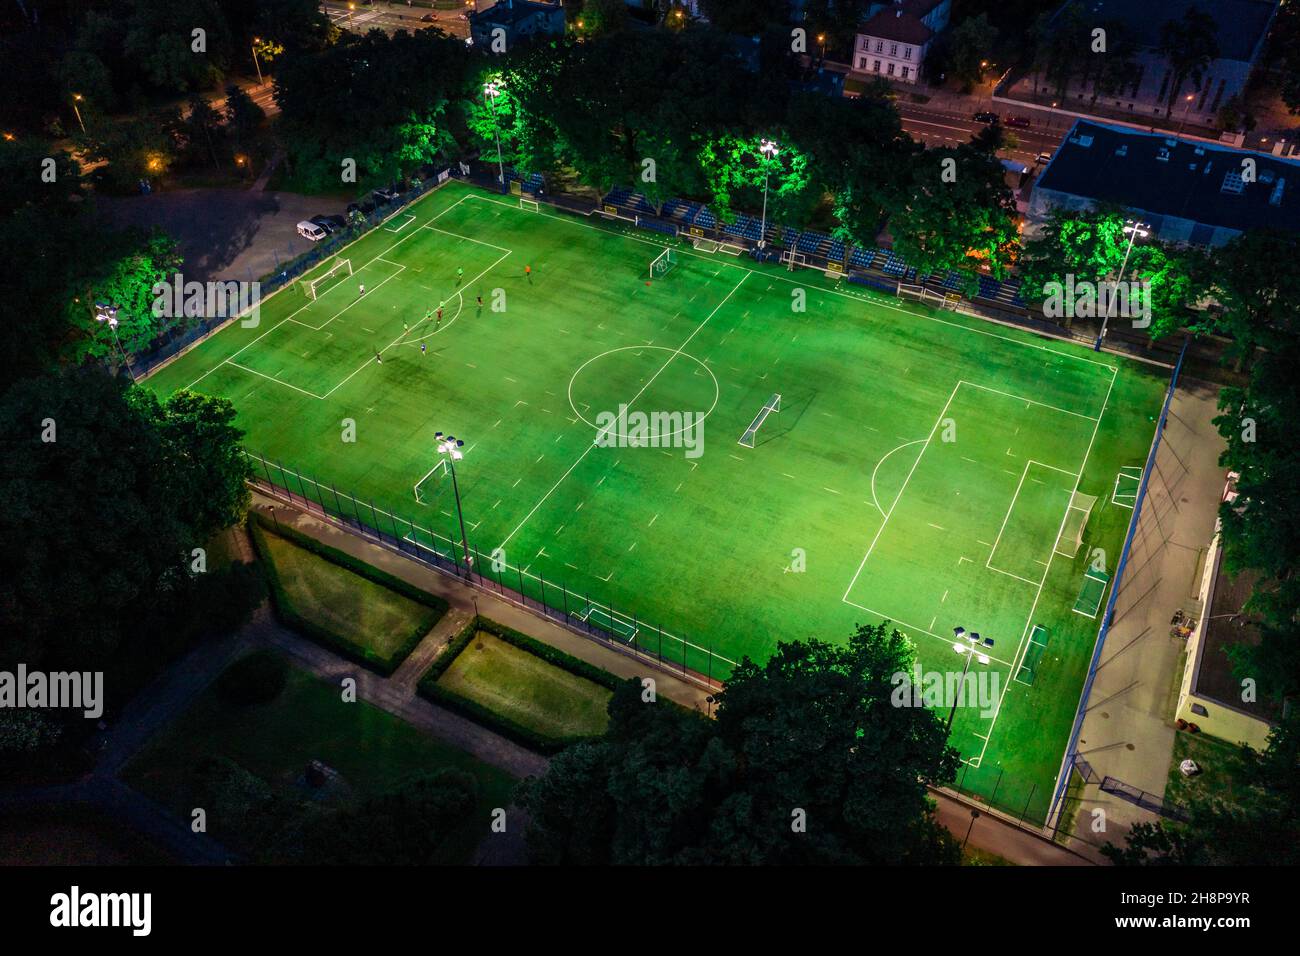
<box><xmin>1036</xmin><ymin>120</ymin><xmax>1300</xmax><ymax>232</ymax></box>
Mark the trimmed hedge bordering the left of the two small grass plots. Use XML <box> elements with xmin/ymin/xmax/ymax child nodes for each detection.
<box><xmin>248</xmin><ymin>511</ymin><xmax>449</xmax><ymax>676</ymax></box>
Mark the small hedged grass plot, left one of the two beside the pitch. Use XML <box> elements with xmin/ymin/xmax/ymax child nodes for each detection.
<box><xmin>256</xmin><ymin>522</ymin><xmax>442</xmax><ymax>661</ymax></box>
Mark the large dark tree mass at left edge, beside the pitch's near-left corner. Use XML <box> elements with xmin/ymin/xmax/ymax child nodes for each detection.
<box><xmin>0</xmin><ymin>367</ymin><xmax>248</xmax><ymax>670</ymax></box>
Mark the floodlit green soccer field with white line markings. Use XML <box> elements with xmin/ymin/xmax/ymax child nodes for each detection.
<box><xmin>147</xmin><ymin>183</ymin><xmax>1167</xmax><ymax>816</ymax></box>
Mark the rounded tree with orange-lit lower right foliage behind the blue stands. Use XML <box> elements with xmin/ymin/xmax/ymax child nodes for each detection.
<box><xmin>889</xmin><ymin>144</ymin><xmax>1019</xmax><ymax>276</ymax></box>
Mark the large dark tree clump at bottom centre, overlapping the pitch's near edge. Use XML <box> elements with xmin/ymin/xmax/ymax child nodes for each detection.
<box><xmin>520</xmin><ymin>624</ymin><xmax>958</xmax><ymax>865</ymax></box>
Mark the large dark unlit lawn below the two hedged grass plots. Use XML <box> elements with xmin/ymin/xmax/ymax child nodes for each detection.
<box><xmin>125</xmin><ymin>660</ymin><xmax>515</xmax><ymax>862</ymax></box>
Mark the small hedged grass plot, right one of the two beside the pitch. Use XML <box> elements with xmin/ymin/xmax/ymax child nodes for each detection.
<box><xmin>438</xmin><ymin>631</ymin><xmax>612</xmax><ymax>739</ymax></box>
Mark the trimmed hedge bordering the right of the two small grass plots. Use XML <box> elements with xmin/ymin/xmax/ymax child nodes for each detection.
<box><xmin>419</xmin><ymin>617</ymin><xmax>623</xmax><ymax>754</ymax></box>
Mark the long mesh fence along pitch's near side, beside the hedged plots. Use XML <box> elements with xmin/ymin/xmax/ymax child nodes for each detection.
<box><xmin>244</xmin><ymin>450</ymin><xmax>736</xmax><ymax>689</ymax></box>
